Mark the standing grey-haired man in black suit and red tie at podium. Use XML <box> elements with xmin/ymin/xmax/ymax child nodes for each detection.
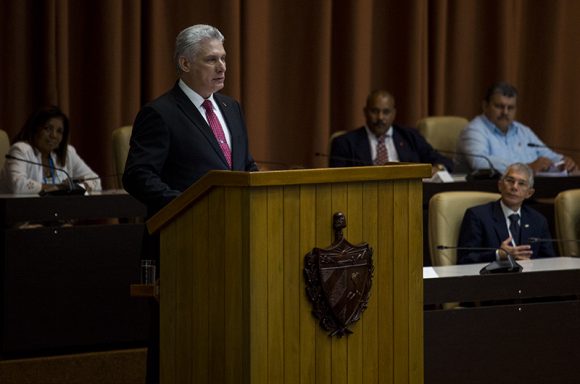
<box><xmin>123</xmin><ymin>25</ymin><xmax>258</xmax><ymax>383</ymax></box>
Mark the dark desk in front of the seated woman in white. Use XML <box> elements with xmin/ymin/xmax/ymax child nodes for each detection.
<box><xmin>0</xmin><ymin>192</ymin><xmax>149</xmax><ymax>359</ymax></box>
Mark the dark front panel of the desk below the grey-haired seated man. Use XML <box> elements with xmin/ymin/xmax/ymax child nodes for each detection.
<box><xmin>424</xmin><ymin>300</ymin><xmax>580</xmax><ymax>384</ymax></box>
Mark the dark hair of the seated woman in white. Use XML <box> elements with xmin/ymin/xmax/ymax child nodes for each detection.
<box><xmin>14</xmin><ymin>105</ymin><xmax>69</xmax><ymax>167</ymax></box>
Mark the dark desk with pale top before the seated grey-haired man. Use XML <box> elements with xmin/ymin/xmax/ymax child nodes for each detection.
<box><xmin>423</xmin><ymin>257</ymin><xmax>580</xmax><ymax>384</ymax></box>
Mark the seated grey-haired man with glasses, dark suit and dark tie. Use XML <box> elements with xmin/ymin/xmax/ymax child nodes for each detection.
<box><xmin>457</xmin><ymin>163</ymin><xmax>555</xmax><ymax>264</ymax></box>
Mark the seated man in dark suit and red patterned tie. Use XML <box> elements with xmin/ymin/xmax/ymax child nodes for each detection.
<box><xmin>330</xmin><ymin>90</ymin><xmax>453</xmax><ymax>174</ymax></box>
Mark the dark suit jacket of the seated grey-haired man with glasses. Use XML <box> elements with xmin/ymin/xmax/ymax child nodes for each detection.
<box><xmin>457</xmin><ymin>200</ymin><xmax>556</xmax><ymax>264</ymax></box>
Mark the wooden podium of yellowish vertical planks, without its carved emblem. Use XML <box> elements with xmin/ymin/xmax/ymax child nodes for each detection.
<box><xmin>147</xmin><ymin>163</ymin><xmax>431</xmax><ymax>384</ymax></box>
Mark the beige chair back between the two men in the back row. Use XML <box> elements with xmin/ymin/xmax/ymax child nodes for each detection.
<box><xmin>417</xmin><ymin>116</ymin><xmax>469</xmax><ymax>154</ymax></box>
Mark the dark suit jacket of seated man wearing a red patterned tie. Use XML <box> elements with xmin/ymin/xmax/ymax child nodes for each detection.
<box><xmin>329</xmin><ymin>125</ymin><xmax>453</xmax><ymax>172</ymax></box>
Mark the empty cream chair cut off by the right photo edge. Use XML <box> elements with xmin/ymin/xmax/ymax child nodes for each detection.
<box><xmin>554</xmin><ymin>189</ymin><xmax>580</xmax><ymax>256</ymax></box>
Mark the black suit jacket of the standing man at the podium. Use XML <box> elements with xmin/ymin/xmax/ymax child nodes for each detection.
<box><xmin>123</xmin><ymin>83</ymin><xmax>257</xmax><ymax>215</ymax></box>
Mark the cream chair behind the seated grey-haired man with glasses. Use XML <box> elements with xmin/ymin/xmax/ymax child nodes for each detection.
<box><xmin>429</xmin><ymin>191</ymin><xmax>501</xmax><ymax>266</ymax></box>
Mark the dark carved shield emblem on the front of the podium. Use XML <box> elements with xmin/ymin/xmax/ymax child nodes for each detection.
<box><xmin>304</xmin><ymin>212</ymin><xmax>374</xmax><ymax>337</ymax></box>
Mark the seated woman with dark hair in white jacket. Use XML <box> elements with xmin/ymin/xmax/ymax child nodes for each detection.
<box><xmin>0</xmin><ymin>106</ymin><xmax>101</xmax><ymax>194</ymax></box>
